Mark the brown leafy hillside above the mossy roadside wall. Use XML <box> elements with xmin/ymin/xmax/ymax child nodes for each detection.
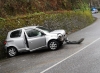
<box><xmin>0</xmin><ymin>0</ymin><xmax>82</xmax><ymax>17</ymax></box>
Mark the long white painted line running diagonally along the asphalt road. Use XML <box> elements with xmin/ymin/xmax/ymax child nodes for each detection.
<box><xmin>40</xmin><ymin>38</ymin><xmax>100</xmax><ymax>73</ymax></box>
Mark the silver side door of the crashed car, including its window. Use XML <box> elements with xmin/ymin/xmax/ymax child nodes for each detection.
<box><xmin>25</xmin><ymin>29</ymin><xmax>46</xmax><ymax>50</ymax></box>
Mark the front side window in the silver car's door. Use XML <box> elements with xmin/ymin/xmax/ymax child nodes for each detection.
<box><xmin>26</xmin><ymin>29</ymin><xmax>42</xmax><ymax>37</ymax></box>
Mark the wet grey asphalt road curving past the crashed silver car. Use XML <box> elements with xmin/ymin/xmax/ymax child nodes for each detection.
<box><xmin>0</xmin><ymin>13</ymin><xmax>100</xmax><ymax>73</ymax></box>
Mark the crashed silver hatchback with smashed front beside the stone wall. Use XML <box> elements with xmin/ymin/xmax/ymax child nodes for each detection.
<box><xmin>5</xmin><ymin>26</ymin><xmax>67</xmax><ymax>57</ymax></box>
